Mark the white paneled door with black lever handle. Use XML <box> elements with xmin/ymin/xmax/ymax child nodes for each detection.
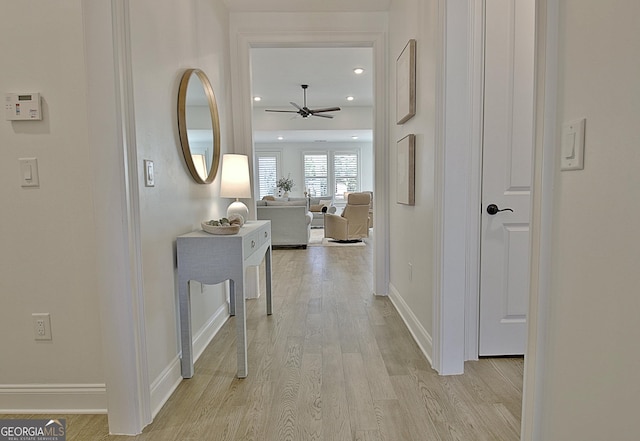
<box><xmin>479</xmin><ymin>0</ymin><xmax>535</xmax><ymax>356</ymax></box>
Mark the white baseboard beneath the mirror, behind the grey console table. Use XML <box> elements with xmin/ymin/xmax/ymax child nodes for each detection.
<box><xmin>151</xmin><ymin>303</ymin><xmax>229</xmax><ymax>418</ymax></box>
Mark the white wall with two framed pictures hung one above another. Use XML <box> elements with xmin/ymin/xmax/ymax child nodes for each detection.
<box><xmin>388</xmin><ymin>0</ymin><xmax>439</xmax><ymax>357</ymax></box>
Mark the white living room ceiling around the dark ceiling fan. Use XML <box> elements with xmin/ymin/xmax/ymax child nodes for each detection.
<box><xmin>251</xmin><ymin>46</ymin><xmax>373</xmax><ymax>142</ymax></box>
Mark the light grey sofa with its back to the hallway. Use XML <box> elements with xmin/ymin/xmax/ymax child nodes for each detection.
<box><xmin>256</xmin><ymin>198</ymin><xmax>313</xmax><ymax>249</ymax></box>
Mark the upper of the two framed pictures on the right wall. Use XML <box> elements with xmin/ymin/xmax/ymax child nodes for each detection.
<box><xmin>396</xmin><ymin>39</ymin><xmax>416</xmax><ymax>124</ymax></box>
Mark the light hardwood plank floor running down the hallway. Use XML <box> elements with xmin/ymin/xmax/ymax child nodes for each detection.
<box><xmin>3</xmin><ymin>244</ymin><xmax>523</xmax><ymax>441</ymax></box>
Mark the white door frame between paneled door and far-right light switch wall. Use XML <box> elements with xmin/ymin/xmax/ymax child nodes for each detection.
<box><xmin>520</xmin><ymin>0</ymin><xmax>560</xmax><ymax>441</ymax></box>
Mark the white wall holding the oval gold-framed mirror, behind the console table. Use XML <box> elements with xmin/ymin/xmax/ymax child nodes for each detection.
<box><xmin>130</xmin><ymin>0</ymin><xmax>233</xmax><ymax>407</ymax></box>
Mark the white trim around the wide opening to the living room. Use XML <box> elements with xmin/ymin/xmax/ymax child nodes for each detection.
<box><xmin>231</xmin><ymin>31</ymin><xmax>389</xmax><ymax>295</ymax></box>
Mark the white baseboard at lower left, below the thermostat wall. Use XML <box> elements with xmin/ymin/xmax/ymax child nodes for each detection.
<box><xmin>0</xmin><ymin>383</ymin><xmax>107</xmax><ymax>414</ymax></box>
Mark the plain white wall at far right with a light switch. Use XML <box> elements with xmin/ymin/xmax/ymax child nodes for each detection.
<box><xmin>536</xmin><ymin>0</ymin><xmax>640</xmax><ymax>441</ymax></box>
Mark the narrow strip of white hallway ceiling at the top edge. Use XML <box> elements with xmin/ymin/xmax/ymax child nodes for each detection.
<box><xmin>224</xmin><ymin>0</ymin><xmax>391</xmax><ymax>12</ymax></box>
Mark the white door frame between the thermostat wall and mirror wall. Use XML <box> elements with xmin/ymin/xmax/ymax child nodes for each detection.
<box><xmin>82</xmin><ymin>0</ymin><xmax>152</xmax><ymax>435</ymax></box>
